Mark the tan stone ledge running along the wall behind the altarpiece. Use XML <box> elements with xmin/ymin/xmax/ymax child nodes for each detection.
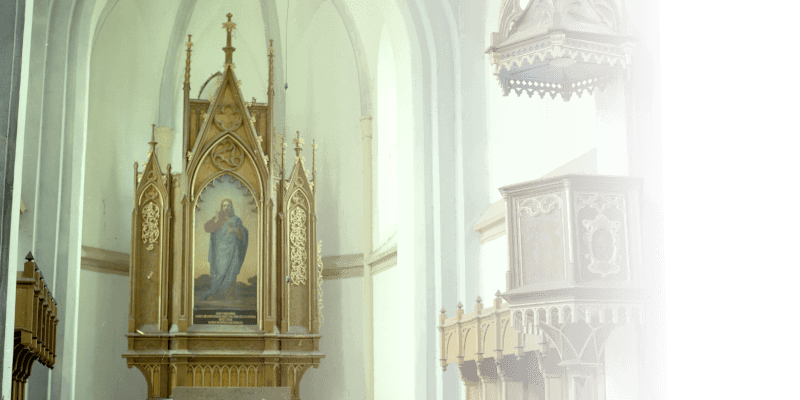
<box><xmin>81</xmin><ymin>245</ymin><xmax>397</xmax><ymax>280</ymax></box>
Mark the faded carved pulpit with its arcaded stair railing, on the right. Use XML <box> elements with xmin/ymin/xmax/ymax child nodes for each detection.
<box><xmin>439</xmin><ymin>175</ymin><xmax>645</xmax><ymax>400</ymax></box>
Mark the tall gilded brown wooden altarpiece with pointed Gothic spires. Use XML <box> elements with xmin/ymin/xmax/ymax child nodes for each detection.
<box><xmin>122</xmin><ymin>14</ymin><xmax>325</xmax><ymax>399</ymax></box>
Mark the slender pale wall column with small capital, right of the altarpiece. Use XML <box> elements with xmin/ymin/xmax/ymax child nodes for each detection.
<box><xmin>359</xmin><ymin>115</ymin><xmax>375</xmax><ymax>400</ymax></box>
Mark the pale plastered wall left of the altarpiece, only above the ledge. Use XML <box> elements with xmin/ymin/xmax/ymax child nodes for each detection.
<box><xmin>83</xmin><ymin>0</ymin><xmax>183</xmax><ymax>253</ymax></box>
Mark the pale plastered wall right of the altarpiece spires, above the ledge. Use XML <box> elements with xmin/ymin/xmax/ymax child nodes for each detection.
<box><xmin>277</xmin><ymin>3</ymin><xmax>363</xmax><ymax>256</ymax></box>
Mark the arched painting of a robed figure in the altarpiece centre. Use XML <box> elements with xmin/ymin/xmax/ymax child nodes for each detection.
<box><xmin>193</xmin><ymin>174</ymin><xmax>258</xmax><ymax>325</ymax></box>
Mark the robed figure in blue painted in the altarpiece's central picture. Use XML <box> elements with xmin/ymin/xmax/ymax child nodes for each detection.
<box><xmin>200</xmin><ymin>199</ymin><xmax>247</xmax><ymax>300</ymax></box>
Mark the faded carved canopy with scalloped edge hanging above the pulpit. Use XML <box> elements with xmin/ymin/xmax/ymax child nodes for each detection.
<box><xmin>486</xmin><ymin>0</ymin><xmax>637</xmax><ymax>101</ymax></box>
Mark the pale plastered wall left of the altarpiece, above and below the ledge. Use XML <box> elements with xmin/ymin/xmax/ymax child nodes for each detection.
<box><xmin>76</xmin><ymin>0</ymin><xmax>184</xmax><ymax>399</ymax></box>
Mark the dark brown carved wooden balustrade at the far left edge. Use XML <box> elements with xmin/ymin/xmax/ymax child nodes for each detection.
<box><xmin>11</xmin><ymin>252</ymin><xmax>58</xmax><ymax>400</ymax></box>
